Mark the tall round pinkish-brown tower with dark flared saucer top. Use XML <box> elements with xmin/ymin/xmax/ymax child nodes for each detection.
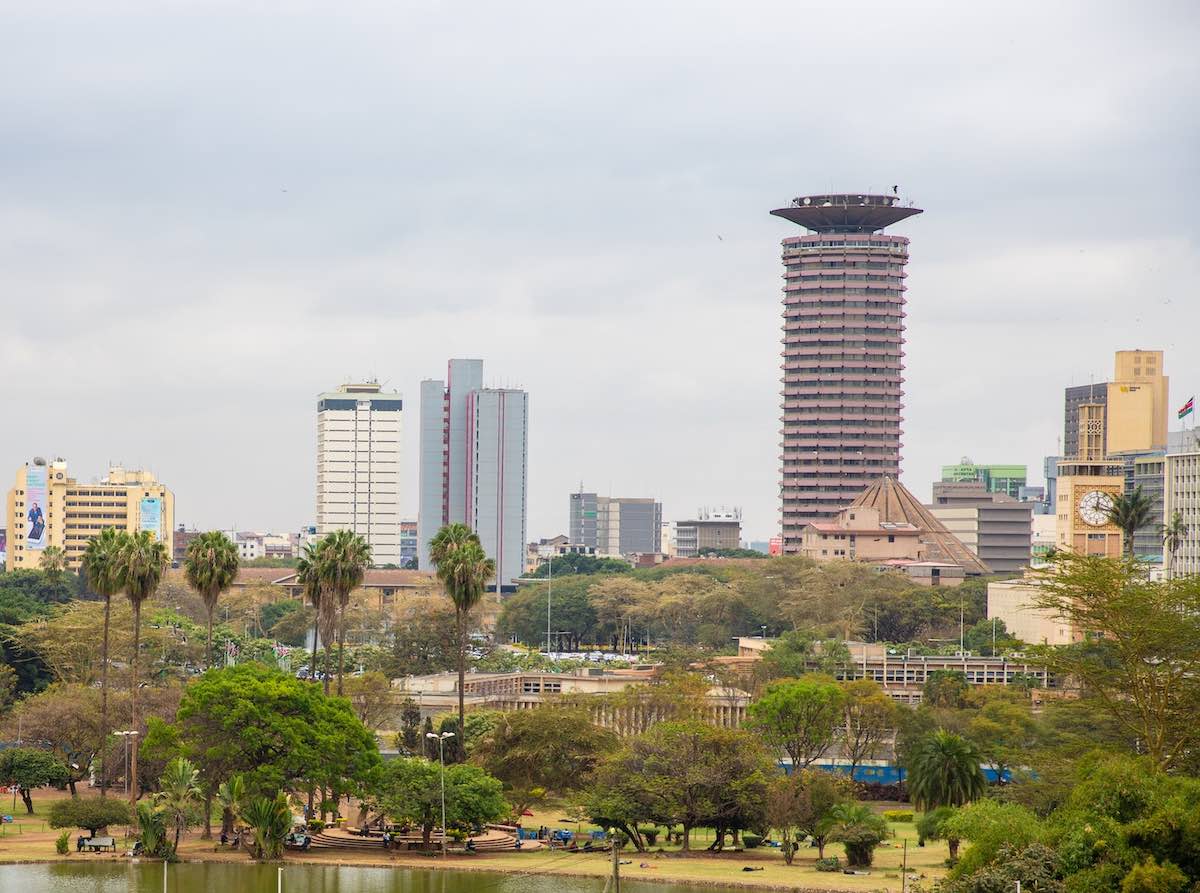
<box><xmin>772</xmin><ymin>194</ymin><xmax>920</xmax><ymax>552</ymax></box>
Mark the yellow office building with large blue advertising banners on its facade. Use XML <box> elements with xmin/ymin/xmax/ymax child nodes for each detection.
<box><xmin>5</xmin><ymin>459</ymin><xmax>175</xmax><ymax>570</ymax></box>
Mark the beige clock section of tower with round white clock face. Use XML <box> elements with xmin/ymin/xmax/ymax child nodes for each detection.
<box><xmin>1055</xmin><ymin>460</ymin><xmax>1124</xmax><ymax>558</ymax></box>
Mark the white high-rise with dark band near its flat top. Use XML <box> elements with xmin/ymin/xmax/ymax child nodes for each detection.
<box><xmin>317</xmin><ymin>382</ymin><xmax>403</xmax><ymax>564</ymax></box>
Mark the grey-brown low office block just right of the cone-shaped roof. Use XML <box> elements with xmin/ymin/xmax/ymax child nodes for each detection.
<box><xmin>929</xmin><ymin>480</ymin><xmax>1033</xmax><ymax>574</ymax></box>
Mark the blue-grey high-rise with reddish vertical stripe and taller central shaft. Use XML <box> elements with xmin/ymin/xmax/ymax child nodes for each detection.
<box><xmin>418</xmin><ymin>360</ymin><xmax>529</xmax><ymax>589</ymax></box>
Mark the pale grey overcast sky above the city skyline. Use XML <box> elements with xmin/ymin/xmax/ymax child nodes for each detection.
<box><xmin>0</xmin><ymin>0</ymin><xmax>1200</xmax><ymax>539</ymax></box>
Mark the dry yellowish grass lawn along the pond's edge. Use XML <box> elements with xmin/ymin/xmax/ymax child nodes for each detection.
<box><xmin>0</xmin><ymin>790</ymin><xmax>948</xmax><ymax>893</ymax></box>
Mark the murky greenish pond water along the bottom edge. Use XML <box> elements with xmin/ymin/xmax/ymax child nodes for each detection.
<box><xmin>0</xmin><ymin>862</ymin><xmax>713</xmax><ymax>893</ymax></box>
